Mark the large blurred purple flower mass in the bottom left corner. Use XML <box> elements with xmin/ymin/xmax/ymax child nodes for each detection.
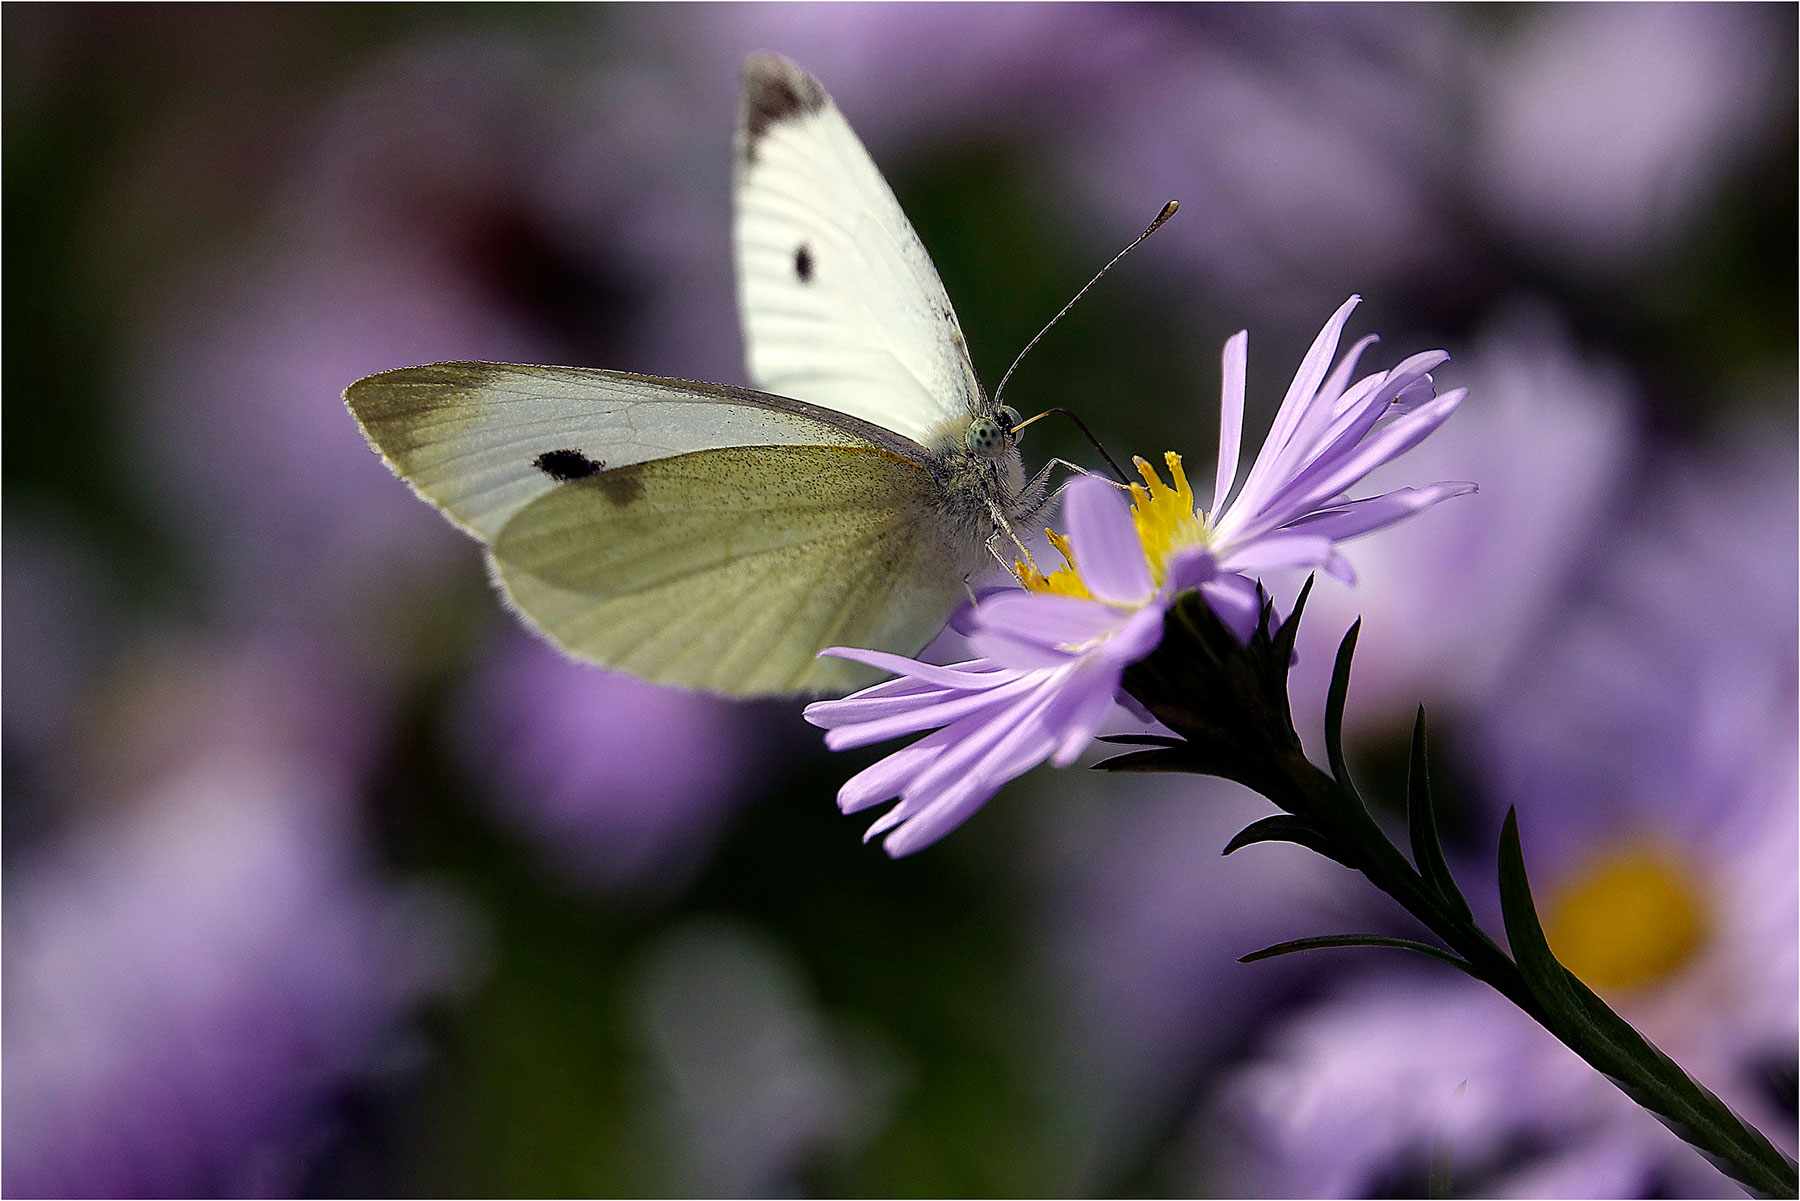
<box><xmin>4</xmin><ymin>657</ymin><xmax>464</xmax><ymax>1196</ymax></box>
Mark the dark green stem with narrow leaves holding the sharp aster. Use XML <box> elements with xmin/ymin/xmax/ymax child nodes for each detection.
<box><xmin>1100</xmin><ymin>585</ymin><xmax>1800</xmax><ymax>1197</ymax></box>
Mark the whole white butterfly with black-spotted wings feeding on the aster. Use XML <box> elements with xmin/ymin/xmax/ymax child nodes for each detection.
<box><xmin>344</xmin><ymin>58</ymin><xmax>1037</xmax><ymax>695</ymax></box>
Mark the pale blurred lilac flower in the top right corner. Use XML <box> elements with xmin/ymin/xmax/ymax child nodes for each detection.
<box><xmin>1467</xmin><ymin>4</ymin><xmax>1793</xmax><ymax>272</ymax></box>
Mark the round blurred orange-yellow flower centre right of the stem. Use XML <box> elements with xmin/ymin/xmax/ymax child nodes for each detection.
<box><xmin>1544</xmin><ymin>844</ymin><xmax>1708</xmax><ymax>999</ymax></box>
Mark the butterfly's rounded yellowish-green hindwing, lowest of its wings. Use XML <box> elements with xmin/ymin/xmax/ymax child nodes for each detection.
<box><xmin>491</xmin><ymin>447</ymin><xmax>972</xmax><ymax>695</ymax></box>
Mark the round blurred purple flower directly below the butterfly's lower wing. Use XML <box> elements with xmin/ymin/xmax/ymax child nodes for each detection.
<box><xmin>454</xmin><ymin>632</ymin><xmax>763</xmax><ymax>891</ymax></box>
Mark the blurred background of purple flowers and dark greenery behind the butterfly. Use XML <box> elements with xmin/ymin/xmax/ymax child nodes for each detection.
<box><xmin>0</xmin><ymin>5</ymin><xmax>1796</xmax><ymax>1196</ymax></box>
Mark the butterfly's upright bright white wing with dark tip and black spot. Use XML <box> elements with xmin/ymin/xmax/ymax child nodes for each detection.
<box><xmin>736</xmin><ymin>56</ymin><xmax>983</xmax><ymax>445</ymax></box>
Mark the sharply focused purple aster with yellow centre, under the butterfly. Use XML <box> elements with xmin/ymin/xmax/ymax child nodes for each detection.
<box><xmin>806</xmin><ymin>297</ymin><xmax>1474</xmax><ymax>855</ymax></box>
